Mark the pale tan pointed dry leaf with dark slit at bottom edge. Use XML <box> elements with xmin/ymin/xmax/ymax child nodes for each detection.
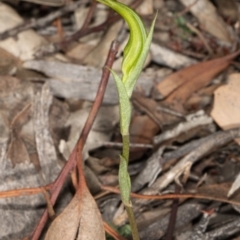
<box><xmin>45</xmin><ymin>187</ymin><xmax>105</xmax><ymax>240</ymax></box>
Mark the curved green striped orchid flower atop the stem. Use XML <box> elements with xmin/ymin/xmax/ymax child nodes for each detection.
<box><xmin>97</xmin><ymin>0</ymin><xmax>157</xmax><ymax>98</ymax></box>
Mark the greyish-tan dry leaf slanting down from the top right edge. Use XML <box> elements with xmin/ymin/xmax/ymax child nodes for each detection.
<box><xmin>181</xmin><ymin>0</ymin><xmax>233</xmax><ymax>43</ymax></box>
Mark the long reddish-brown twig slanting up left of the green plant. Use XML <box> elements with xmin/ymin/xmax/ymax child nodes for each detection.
<box><xmin>31</xmin><ymin>39</ymin><xmax>119</xmax><ymax>240</ymax></box>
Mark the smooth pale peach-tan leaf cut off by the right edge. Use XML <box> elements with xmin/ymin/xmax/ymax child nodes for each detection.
<box><xmin>211</xmin><ymin>73</ymin><xmax>240</xmax><ymax>144</ymax></box>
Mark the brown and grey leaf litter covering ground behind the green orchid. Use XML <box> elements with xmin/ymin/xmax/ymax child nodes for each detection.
<box><xmin>0</xmin><ymin>0</ymin><xmax>240</xmax><ymax>240</ymax></box>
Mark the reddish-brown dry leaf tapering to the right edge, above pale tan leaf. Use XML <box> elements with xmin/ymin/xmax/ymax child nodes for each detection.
<box><xmin>157</xmin><ymin>51</ymin><xmax>240</xmax><ymax>103</ymax></box>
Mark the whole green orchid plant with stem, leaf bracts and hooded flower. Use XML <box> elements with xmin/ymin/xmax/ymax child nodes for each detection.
<box><xmin>97</xmin><ymin>0</ymin><xmax>156</xmax><ymax>239</ymax></box>
